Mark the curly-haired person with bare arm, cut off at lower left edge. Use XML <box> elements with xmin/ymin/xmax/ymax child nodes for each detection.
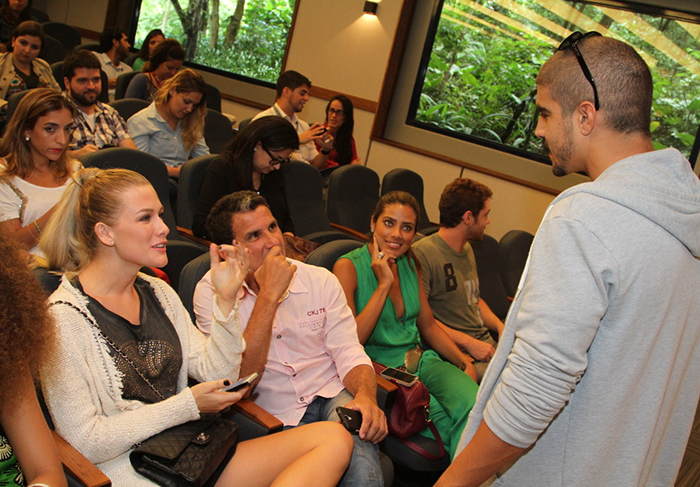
<box><xmin>0</xmin><ymin>230</ymin><xmax>66</xmax><ymax>487</ymax></box>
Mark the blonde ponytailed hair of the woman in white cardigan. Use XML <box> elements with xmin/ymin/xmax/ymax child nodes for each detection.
<box><xmin>39</xmin><ymin>167</ymin><xmax>150</xmax><ymax>278</ymax></box>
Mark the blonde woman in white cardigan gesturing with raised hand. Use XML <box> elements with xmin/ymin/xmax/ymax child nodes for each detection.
<box><xmin>41</xmin><ymin>169</ymin><xmax>352</xmax><ymax>487</ymax></box>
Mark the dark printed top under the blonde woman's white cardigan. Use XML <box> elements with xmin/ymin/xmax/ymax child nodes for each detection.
<box><xmin>71</xmin><ymin>278</ymin><xmax>182</xmax><ymax>404</ymax></box>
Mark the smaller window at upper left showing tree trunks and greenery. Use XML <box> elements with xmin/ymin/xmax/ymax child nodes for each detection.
<box><xmin>134</xmin><ymin>0</ymin><xmax>295</xmax><ymax>84</ymax></box>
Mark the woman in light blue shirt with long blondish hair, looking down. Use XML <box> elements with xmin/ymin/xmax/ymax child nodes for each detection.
<box><xmin>127</xmin><ymin>69</ymin><xmax>209</xmax><ymax>178</ymax></box>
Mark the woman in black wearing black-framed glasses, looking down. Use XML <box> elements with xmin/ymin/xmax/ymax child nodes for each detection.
<box><xmin>192</xmin><ymin>117</ymin><xmax>299</xmax><ymax>238</ymax></box>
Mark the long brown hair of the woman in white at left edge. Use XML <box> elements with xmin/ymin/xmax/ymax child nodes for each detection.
<box><xmin>0</xmin><ymin>88</ymin><xmax>75</xmax><ymax>182</ymax></box>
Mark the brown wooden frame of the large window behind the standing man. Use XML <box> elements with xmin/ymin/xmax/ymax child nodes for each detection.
<box><xmin>371</xmin><ymin>0</ymin><xmax>700</xmax><ymax>195</ymax></box>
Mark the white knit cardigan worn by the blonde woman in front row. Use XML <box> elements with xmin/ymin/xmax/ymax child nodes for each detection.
<box><xmin>41</xmin><ymin>275</ymin><xmax>245</xmax><ymax>487</ymax></box>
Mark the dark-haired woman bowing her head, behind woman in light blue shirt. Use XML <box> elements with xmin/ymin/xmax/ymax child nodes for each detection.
<box><xmin>124</xmin><ymin>39</ymin><xmax>185</xmax><ymax>101</ymax></box>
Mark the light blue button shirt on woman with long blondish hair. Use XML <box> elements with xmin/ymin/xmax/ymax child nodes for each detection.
<box><xmin>127</xmin><ymin>103</ymin><xmax>209</xmax><ymax>167</ymax></box>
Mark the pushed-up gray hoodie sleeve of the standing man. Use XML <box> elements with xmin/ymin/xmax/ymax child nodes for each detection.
<box><xmin>484</xmin><ymin>212</ymin><xmax>617</xmax><ymax>448</ymax></box>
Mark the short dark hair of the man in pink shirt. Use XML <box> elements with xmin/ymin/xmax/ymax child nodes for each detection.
<box><xmin>206</xmin><ymin>191</ymin><xmax>270</xmax><ymax>245</ymax></box>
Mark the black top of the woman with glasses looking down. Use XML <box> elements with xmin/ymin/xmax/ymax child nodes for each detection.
<box><xmin>192</xmin><ymin>157</ymin><xmax>294</xmax><ymax>239</ymax></box>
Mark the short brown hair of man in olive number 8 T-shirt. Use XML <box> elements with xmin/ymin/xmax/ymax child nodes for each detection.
<box><xmin>438</xmin><ymin>178</ymin><xmax>493</xmax><ymax>228</ymax></box>
